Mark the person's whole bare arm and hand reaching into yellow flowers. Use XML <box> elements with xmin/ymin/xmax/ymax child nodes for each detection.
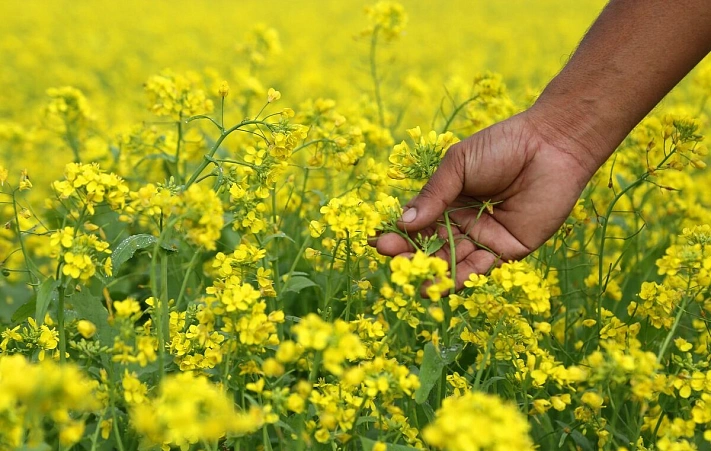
<box><xmin>377</xmin><ymin>0</ymin><xmax>711</xmax><ymax>288</ymax></box>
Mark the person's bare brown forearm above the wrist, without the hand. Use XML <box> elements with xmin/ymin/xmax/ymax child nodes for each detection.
<box><xmin>531</xmin><ymin>0</ymin><xmax>711</xmax><ymax>175</ymax></box>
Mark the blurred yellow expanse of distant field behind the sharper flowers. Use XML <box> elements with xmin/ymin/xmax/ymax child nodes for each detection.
<box><xmin>0</xmin><ymin>0</ymin><xmax>604</xmax><ymax>121</ymax></box>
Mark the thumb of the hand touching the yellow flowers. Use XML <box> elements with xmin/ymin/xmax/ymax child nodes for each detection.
<box><xmin>398</xmin><ymin>143</ymin><xmax>464</xmax><ymax>232</ymax></box>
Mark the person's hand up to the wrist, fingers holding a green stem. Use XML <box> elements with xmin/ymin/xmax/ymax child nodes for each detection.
<box><xmin>376</xmin><ymin>110</ymin><xmax>598</xmax><ymax>289</ymax></box>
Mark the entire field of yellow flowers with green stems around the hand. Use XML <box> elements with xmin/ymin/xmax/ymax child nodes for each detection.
<box><xmin>0</xmin><ymin>0</ymin><xmax>711</xmax><ymax>451</ymax></box>
